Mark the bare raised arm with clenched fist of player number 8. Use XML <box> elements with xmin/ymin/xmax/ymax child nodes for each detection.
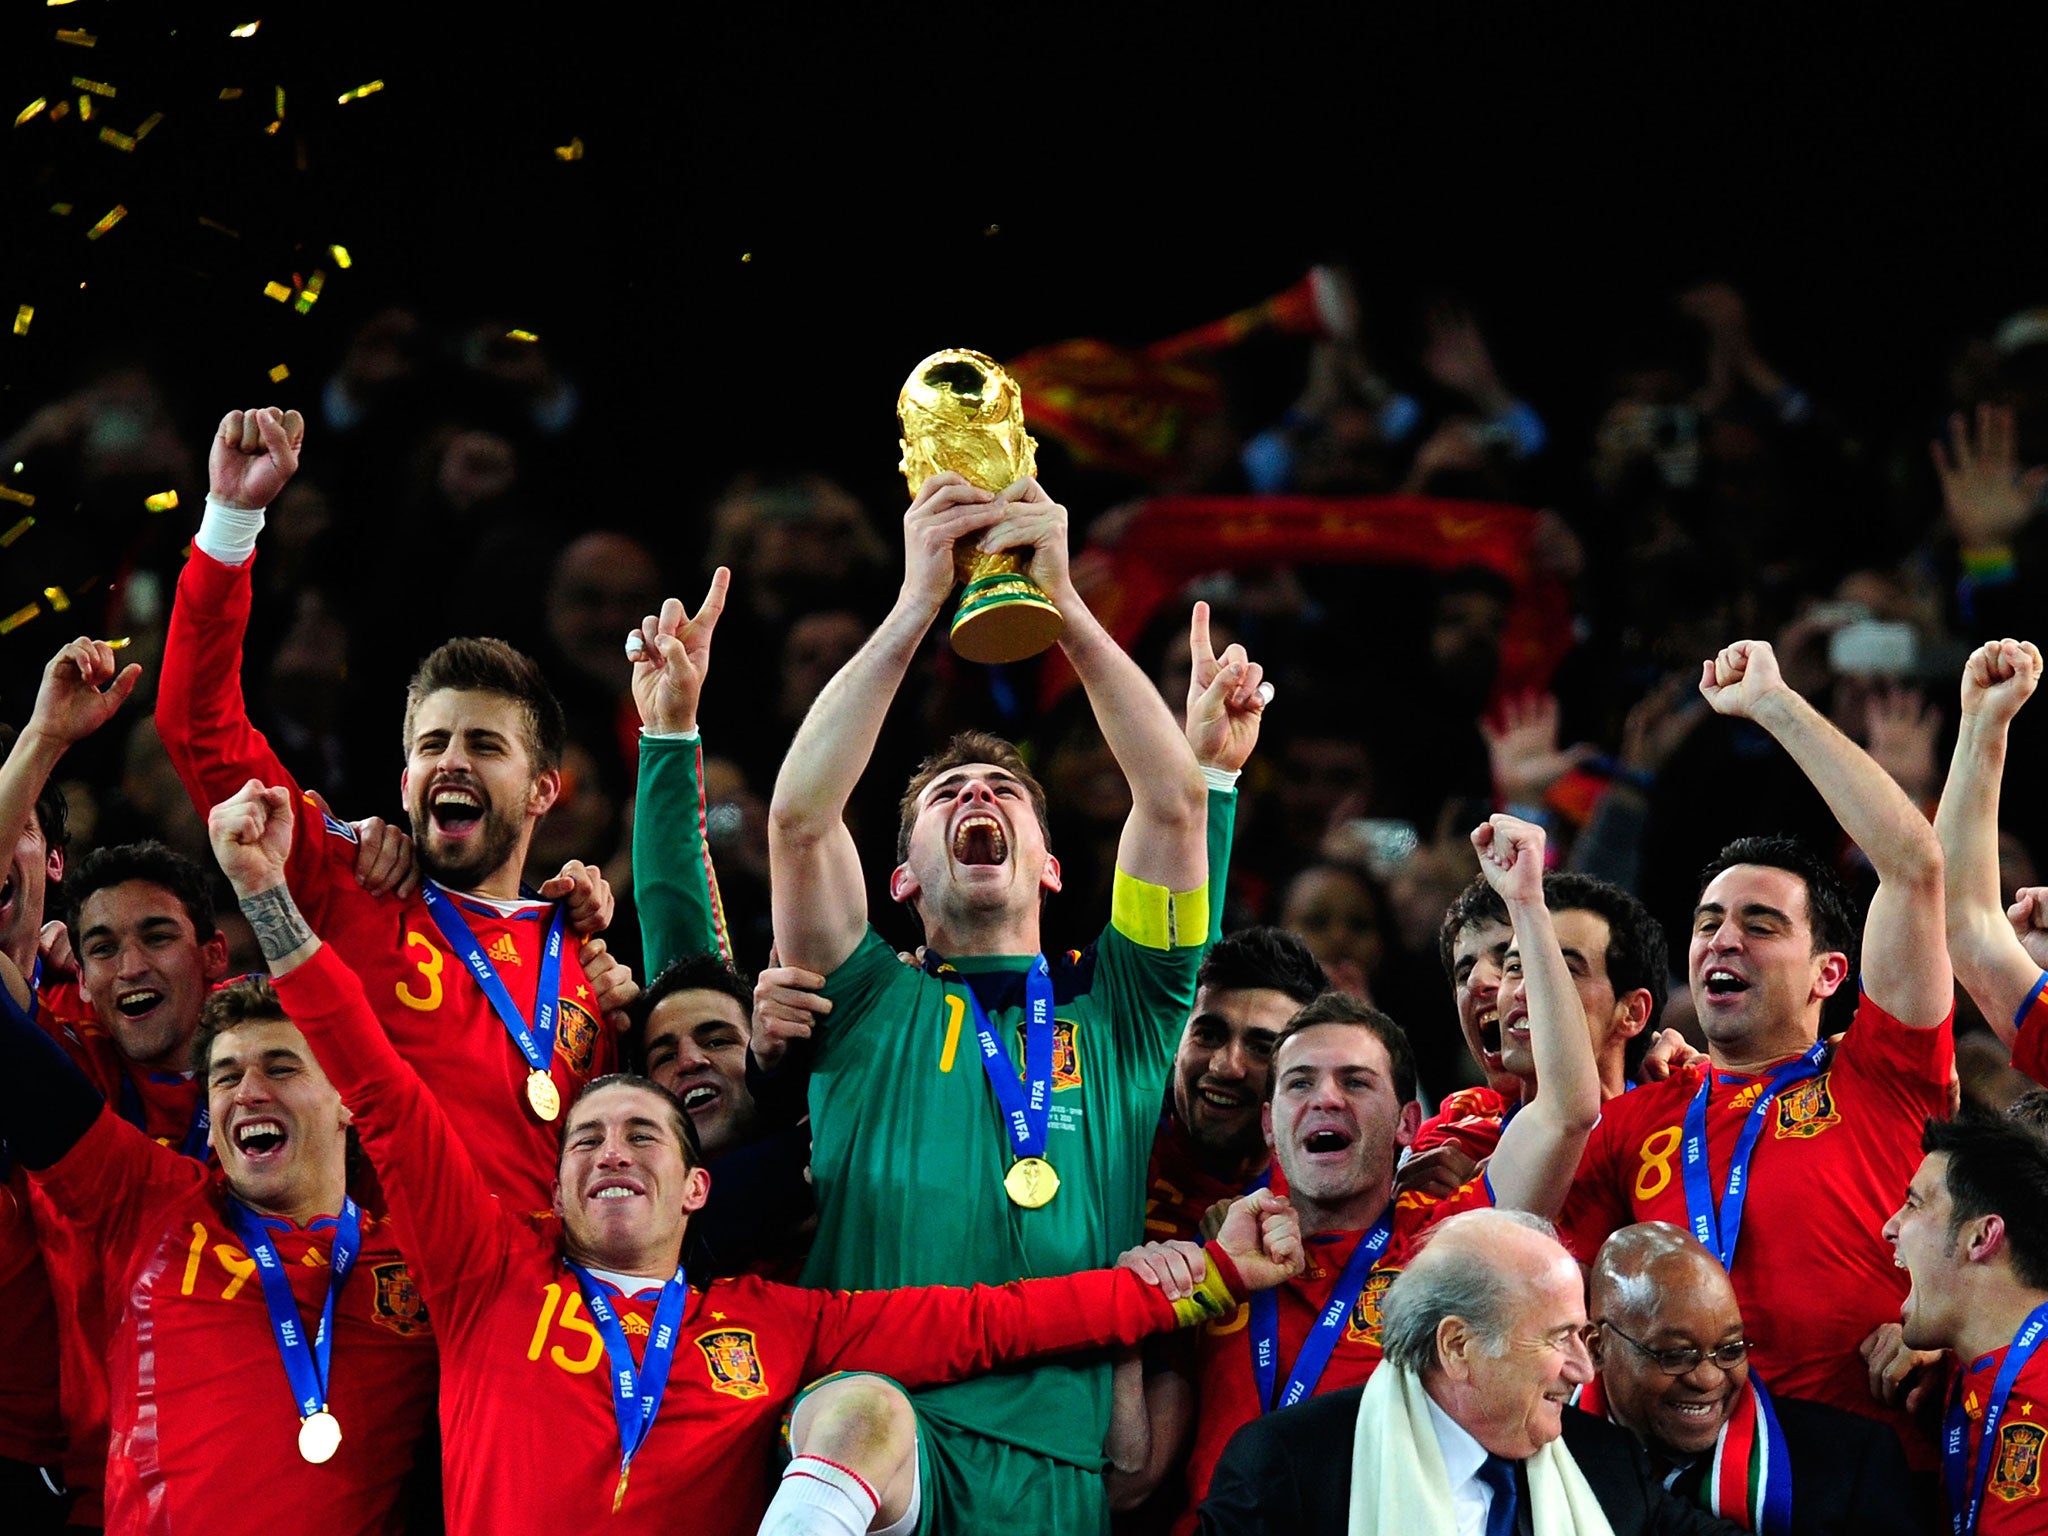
<box><xmin>1700</xmin><ymin>641</ymin><xmax>1954</xmax><ymax>1028</ymax></box>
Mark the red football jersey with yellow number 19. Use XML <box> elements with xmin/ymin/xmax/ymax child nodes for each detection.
<box><xmin>31</xmin><ymin>1110</ymin><xmax>434</xmax><ymax>1536</ymax></box>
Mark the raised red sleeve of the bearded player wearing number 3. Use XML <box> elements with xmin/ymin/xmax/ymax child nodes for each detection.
<box><xmin>156</xmin><ymin>547</ymin><xmax>330</xmax><ymax>926</ymax></box>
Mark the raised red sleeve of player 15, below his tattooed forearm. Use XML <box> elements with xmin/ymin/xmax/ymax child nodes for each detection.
<box><xmin>276</xmin><ymin>944</ymin><xmax>518</xmax><ymax>1325</ymax></box>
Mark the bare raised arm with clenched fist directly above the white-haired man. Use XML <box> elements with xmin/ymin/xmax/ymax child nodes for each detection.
<box><xmin>1473</xmin><ymin>815</ymin><xmax>1599</xmax><ymax>1217</ymax></box>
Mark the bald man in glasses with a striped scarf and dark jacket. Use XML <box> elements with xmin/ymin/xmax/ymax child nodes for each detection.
<box><xmin>1577</xmin><ymin>1221</ymin><xmax>1933</xmax><ymax>1536</ymax></box>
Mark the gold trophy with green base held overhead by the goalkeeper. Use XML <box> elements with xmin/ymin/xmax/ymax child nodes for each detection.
<box><xmin>897</xmin><ymin>348</ymin><xmax>1065</xmax><ymax>662</ymax></box>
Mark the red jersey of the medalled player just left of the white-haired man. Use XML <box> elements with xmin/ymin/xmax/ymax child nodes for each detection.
<box><xmin>1174</xmin><ymin>1174</ymin><xmax>1493</xmax><ymax>1536</ymax></box>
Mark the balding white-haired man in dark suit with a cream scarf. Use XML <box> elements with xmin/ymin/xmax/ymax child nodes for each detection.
<box><xmin>1202</xmin><ymin>1210</ymin><xmax>1737</xmax><ymax>1536</ymax></box>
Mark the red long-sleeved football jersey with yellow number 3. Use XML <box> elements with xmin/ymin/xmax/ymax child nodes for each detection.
<box><xmin>156</xmin><ymin>549</ymin><xmax>618</xmax><ymax>1212</ymax></box>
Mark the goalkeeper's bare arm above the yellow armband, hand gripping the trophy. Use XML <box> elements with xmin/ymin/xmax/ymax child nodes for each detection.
<box><xmin>983</xmin><ymin>479</ymin><xmax>1204</xmax><ymax>888</ymax></box>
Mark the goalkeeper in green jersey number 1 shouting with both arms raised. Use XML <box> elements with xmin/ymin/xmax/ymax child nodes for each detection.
<box><xmin>768</xmin><ymin>473</ymin><xmax>1264</xmax><ymax>1536</ymax></box>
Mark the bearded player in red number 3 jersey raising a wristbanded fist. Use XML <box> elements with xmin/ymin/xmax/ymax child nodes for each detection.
<box><xmin>156</xmin><ymin>410</ymin><xmax>616</xmax><ymax>1210</ymax></box>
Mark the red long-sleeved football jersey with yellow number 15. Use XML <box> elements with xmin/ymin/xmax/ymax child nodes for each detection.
<box><xmin>276</xmin><ymin>948</ymin><xmax>1228</xmax><ymax>1536</ymax></box>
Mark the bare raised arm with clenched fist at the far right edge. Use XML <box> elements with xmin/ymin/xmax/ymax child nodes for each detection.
<box><xmin>1933</xmin><ymin>639</ymin><xmax>2042</xmax><ymax>1044</ymax></box>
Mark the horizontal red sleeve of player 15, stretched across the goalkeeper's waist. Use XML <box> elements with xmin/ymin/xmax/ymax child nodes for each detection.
<box><xmin>805</xmin><ymin>1247</ymin><xmax>1243</xmax><ymax>1386</ymax></box>
